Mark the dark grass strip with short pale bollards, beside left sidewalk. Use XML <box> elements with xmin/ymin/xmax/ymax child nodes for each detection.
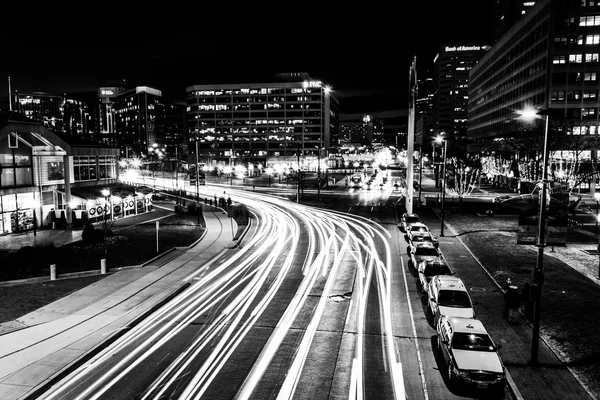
<box><xmin>0</xmin><ymin>214</ymin><xmax>204</xmax><ymax>281</ymax></box>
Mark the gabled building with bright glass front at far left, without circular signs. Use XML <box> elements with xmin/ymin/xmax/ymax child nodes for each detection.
<box><xmin>0</xmin><ymin>121</ymin><xmax>119</xmax><ymax>235</ymax></box>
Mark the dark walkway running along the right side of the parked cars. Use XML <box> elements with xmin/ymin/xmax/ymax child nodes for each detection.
<box><xmin>416</xmin><ymin>173</ymin><xmax>591</xmax><ymax>400</ymax></box>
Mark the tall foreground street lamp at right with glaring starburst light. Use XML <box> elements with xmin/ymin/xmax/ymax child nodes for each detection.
<box><xmin>518</xmin><ymin>107</ymin><xmax>550</xmax><ymax>365</ymax></box>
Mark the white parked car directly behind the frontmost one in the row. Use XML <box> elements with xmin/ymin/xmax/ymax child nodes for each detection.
<box><xmin>427</xmin><ymin>275</ymin><xmax>475</xmax><ymax>326</ymax></box>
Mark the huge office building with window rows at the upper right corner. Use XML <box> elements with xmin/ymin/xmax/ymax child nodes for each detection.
<box><xmin>468</xmin><ymin>0</ymin><xmax>600</xmax><ymax>167</ymax></box>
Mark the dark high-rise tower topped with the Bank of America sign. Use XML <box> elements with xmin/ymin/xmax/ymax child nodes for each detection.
<box><xmin>432</xmin><ymin>44</ymin><xmax>490</xmax><ymax>155</ymax></box>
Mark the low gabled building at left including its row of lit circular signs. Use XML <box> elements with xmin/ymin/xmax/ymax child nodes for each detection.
<box><xmin>0</xmin><ymin>113</ymin><xmax>152</xmax><ymax>234</ymax></box>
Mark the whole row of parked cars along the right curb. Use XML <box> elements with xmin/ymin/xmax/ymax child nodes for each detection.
<box><xmin>399</xmin><ymin>213</ymin><xmax>506</xmax><ymax>391</ymax></box>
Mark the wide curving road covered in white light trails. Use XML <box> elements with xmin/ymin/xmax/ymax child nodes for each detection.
<box><xmin>38</xmin><ymin>188</ymin><xmax>404</xmax><ymax>399</ymax></box>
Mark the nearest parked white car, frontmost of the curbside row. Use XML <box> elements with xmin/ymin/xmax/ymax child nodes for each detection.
<box><xmin>437</xmin><ymin>317</ymin><xmax>506</xmax><ymax>390</ymax></box>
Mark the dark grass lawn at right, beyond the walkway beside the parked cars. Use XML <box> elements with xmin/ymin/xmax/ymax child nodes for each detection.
<box><xmin>446</xmin><ymin>214</ymin><xmax>600</xmax><ymax>398</ymax></box>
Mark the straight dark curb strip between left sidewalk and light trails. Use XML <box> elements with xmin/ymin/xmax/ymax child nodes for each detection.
<box><xmin>23</xmin><ymin>282</ymin><xmax>190</xmax><ymax>400</ymax></box>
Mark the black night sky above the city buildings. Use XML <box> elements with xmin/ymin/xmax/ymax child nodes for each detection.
<box><xmin>0</xmin><ymin>0</ymin><xmax>492</xmax><ymax>112</ymax></box>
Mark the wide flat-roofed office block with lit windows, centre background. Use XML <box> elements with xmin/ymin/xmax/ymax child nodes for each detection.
<box><xmin>186</xmin><ymin>73</ymin><xmax>339</xmax><ymax>164</ymax></box>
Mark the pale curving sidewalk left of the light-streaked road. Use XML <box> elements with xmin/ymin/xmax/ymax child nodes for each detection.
<box><xmin>0</xmin><ymin>209</ymin><xmax>237</xmax><ymax>400</ymax></box>
